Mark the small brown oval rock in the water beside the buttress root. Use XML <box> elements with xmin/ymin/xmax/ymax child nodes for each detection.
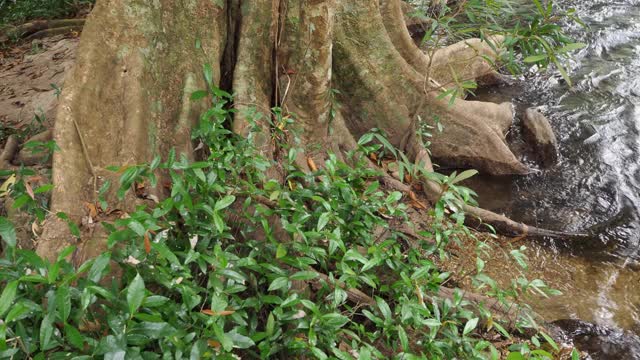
<box><xmin>522</xmin><ymin>108</ymin><xmax>558</xmax><ymax>167</ymax></box>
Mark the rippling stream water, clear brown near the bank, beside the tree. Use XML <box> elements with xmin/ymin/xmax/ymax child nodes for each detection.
<box><xmin>471</xmin><ymin>0</ymin><xmax>640</xmax><ymax>359</ymax></box>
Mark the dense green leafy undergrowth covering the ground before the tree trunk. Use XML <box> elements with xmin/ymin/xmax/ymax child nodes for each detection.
<box><xmin>0</xmin><ymin>83</ymin><xmax>576</xmax><ymax>359</ymax></box>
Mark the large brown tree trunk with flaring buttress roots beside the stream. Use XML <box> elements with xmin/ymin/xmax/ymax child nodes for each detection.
<box><xmin>38</xmin><ymin>0</ymin><xmax>544</xmax><ymax>257</ymax></box>
